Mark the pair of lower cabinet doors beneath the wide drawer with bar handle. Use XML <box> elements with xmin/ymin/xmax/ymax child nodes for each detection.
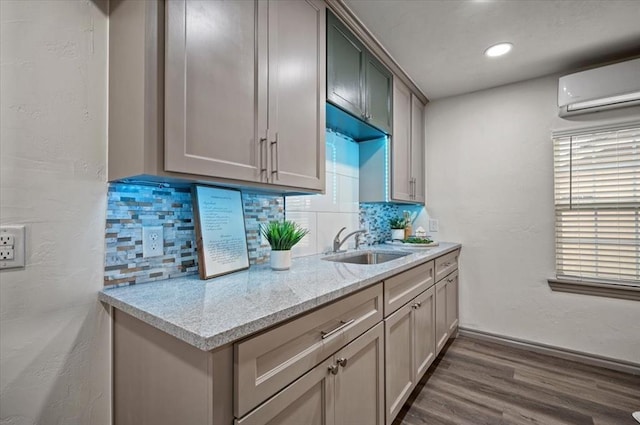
<box><xmin>235</xmin><ymin>323</ymin><xmax>384</xmax><ymax>425</ymax></box>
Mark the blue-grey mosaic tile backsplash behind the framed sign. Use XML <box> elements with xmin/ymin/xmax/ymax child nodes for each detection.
<box><xmin>104</xmin><ymin>183</ymin><xmax>284</xmax><ymax>286</ymax></box>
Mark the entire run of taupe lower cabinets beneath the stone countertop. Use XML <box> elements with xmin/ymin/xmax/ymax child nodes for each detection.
<box><xmin>113</xmin><ymin>250</ymin><xmax>459</xmax><ymax>425</ymax></box>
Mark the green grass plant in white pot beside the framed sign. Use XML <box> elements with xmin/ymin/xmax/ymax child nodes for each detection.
<box><xmin>260</xmin><ymin>220</ymin><xmax>309</xmax><ymax>270</ymax></box>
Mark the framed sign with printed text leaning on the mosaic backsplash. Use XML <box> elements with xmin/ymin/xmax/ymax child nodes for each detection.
<box><xmin>192</xmin><ymin>185</ymin><xmax>249</xmax><ymax>279</ymax></box>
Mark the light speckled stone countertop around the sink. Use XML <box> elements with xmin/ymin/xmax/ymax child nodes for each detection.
<box><xmin>98</xmin><ymin>242</ymin><xmax>460</xmax><ymax>351</ymax></box>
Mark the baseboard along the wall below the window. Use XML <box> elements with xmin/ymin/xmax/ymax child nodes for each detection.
<box><xmin>458</xmin><ymin>327</ymin><xmax>640</xmax><ymax>375</ymax></box>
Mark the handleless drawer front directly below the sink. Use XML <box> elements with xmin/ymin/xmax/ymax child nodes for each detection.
<box><xmin>384</xmin><ymin>261</ymin><xmax>435</xmax><ymax>317</ymax></box>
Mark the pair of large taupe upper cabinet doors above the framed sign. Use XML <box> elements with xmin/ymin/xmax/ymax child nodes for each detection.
<box><xmin>164</xmin><ymin>0</ymin><xmax>326</xmax><ymax>191</ymax></box>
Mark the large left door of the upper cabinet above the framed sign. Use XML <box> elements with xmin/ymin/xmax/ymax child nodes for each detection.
<box><xmin>164</xmin><ymin>0</ymin><xmax>266</xmax><ymax>181</ymax></box>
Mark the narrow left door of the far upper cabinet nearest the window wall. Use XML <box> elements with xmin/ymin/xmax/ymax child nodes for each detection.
<box><xmin>391</xmin><ymin>80</ymin><xmax>412</xmax><ymax>201</ymax></box>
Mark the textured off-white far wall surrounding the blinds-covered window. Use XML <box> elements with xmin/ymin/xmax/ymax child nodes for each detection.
<box><xmin>426</xmin><ymin>72</ymin><xmax>640</xmax><ymax>363</ymax></box>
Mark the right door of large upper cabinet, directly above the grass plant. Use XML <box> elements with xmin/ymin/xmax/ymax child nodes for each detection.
<box><xmin>268</xmin><ymin>0</ymin><xmax>326</xmax><ymax>190</ymax></box>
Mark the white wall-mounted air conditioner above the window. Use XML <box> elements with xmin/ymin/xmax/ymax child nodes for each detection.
<box><xmin>558</xmin><ymin>58</ymin><xmax>640</xmax><ymax>117</ymax></box>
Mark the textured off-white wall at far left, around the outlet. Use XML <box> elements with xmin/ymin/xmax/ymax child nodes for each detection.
<box><xmin>0</xmin><ymin>0</ymin><xmax>110</xmax><ymax>425</ymax></box>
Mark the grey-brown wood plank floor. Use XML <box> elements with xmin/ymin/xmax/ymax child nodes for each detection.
<box><xmin>394</xmin><ymin>336</ymin><xmax>640</xmax><ymax>425</ymax></box>
